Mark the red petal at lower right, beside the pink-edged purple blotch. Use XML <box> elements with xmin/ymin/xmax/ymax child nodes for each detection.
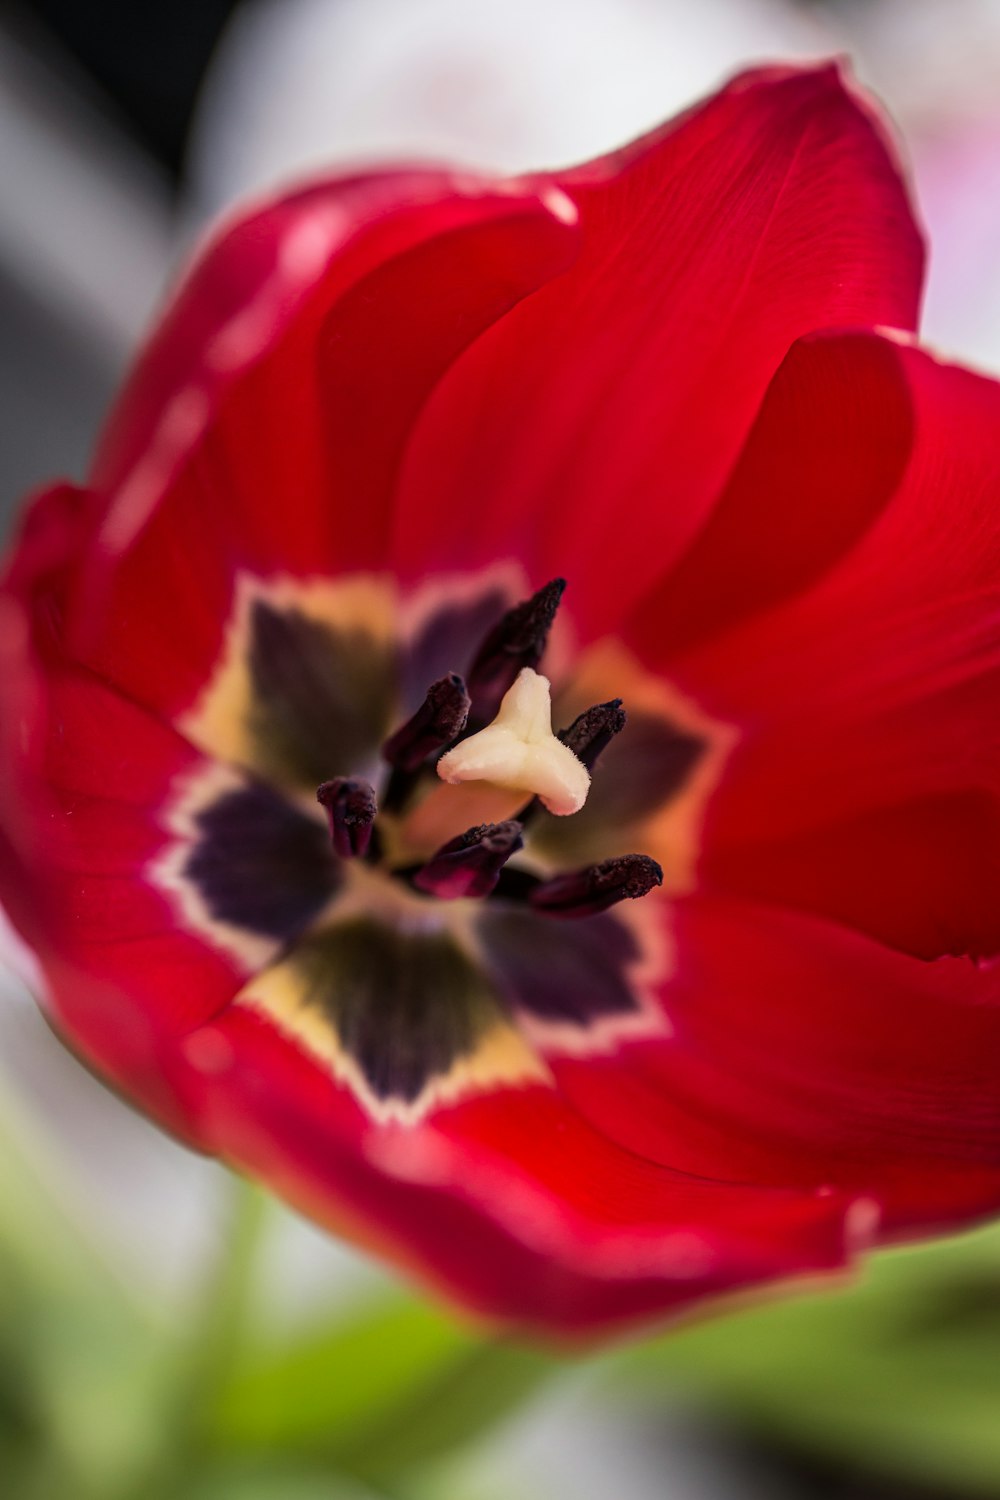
<box><xmin>542</xmin><ymin>897</ymin><xmax>1000</xmax><ymax>1232</ymax></box>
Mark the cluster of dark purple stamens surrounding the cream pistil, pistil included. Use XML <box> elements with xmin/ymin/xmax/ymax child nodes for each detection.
<box><xmin>308</xmin><ymin>579</ymin><xmax>663</xmax><ymax>917</ymax></box>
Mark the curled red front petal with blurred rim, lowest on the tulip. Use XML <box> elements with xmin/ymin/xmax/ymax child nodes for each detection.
<box><xmin>170</xmin><ymin>1008</ymin><xmax>849</xmax><ymax>1332</ymax></box>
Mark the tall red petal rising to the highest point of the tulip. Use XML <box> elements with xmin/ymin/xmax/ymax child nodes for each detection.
<box><xmin>394</xmin><ymin>69</ymin><xmax>922</xmax><ymax>629</ymax></box>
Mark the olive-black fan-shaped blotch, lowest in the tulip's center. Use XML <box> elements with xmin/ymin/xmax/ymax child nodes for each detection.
<box><xmin>292</xmin><ymin>918</ymin><xmax>505</xmax><ymax>1104</ymax></box>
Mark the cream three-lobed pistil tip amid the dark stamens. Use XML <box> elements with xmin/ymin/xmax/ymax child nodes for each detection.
<box><xmin>438</xmin><ymin>666</ymin><xmax>591</xmax><ymax>818</ymax></box>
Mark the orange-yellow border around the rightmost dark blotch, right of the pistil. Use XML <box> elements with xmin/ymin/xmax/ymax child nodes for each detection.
<box><xmin>548</xmin><ymin>639</ymin><xmax>739</xmax><ymax>896</ymax></box>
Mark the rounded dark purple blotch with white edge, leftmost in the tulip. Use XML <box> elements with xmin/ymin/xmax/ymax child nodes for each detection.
<box><xmin>183</xmin><ymin>785</ymin><xmax>339</xmax><ymax>941</ymax></box>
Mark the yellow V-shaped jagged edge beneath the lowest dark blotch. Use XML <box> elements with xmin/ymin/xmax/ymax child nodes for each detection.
<box><xmin>232</xmin><ymin>936</ymin><xmax>552</xmax><ymax>1125</ymax></box>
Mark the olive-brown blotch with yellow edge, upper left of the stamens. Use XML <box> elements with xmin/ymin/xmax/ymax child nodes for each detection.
<box><xmin>247</xmin><ymin>599</ymin><xmax>396</xmax><ymax>791</ymax></box>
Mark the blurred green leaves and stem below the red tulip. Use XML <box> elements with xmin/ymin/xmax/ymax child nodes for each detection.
<box><xmin>0</xmin><ymin>1062</ymin><xmax>1000</xmax><ymax>1500</ymax></box>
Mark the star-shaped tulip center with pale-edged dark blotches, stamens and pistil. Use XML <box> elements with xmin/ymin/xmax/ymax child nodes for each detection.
<box><xmin>160</xmin><ymin>564</ymin><xmax>732</xmax><ymax>1125</ymax></box>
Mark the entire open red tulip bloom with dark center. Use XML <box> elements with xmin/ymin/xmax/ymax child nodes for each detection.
<box><xmin>0</xmin><ymin>55</ymin><xmax>1000</xmax><ymax>1337</ymax></box>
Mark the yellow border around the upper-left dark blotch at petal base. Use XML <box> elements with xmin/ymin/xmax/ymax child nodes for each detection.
<box><xmin>178</xmin><ymin>573</ymin><xmax>397</xmax><ymax>770</ymax></box>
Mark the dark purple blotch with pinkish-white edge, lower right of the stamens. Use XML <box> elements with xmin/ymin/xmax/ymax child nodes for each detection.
<box><xmin>477</xmin><ymin>909</ymin><xmax>639</xmax><ymax>1028</ymax></box>
